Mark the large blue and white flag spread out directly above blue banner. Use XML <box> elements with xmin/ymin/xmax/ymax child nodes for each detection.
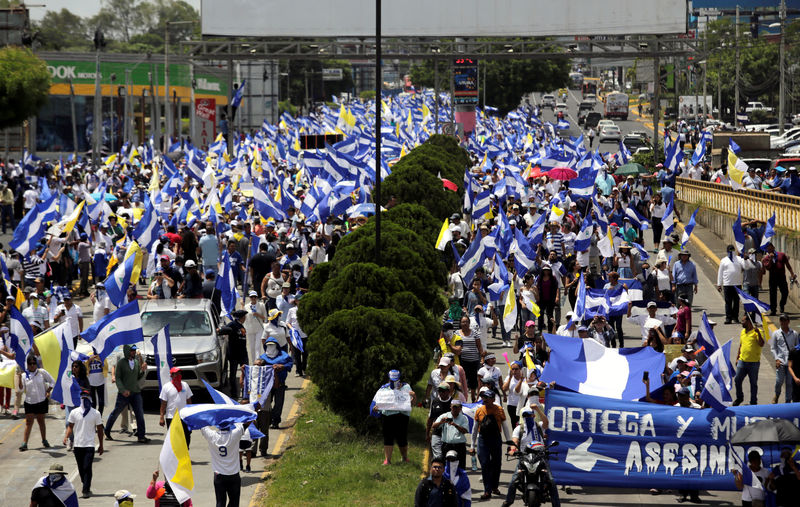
<box><xmin>541</xmin><ymin>333</ymin><xmax>664</xmax><ymax>400</ymax></box>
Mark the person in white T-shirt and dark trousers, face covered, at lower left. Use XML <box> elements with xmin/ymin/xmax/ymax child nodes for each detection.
<box><xmin>64</xmin><ymin>389</ymin><xmax>103</xmax><ymax>498</ymax></box>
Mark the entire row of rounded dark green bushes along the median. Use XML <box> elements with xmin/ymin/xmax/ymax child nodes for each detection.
<box><xmin>298</xmin><ymin>136</ymin><xmax>469</xmax><ymax>431</ymax></box>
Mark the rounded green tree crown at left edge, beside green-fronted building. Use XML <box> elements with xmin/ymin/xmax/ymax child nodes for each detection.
<box><xmin>0</xmin><ymin>46</ymin><xmax>50</xmax><ymax>129</ymax></box>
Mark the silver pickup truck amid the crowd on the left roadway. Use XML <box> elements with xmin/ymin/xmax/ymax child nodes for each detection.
<box><xmin>139</xmin><ymin>299</ymin><xmax>228</xmax><ymax>390</ymax></box>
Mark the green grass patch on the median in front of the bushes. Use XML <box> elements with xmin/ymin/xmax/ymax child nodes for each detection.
<box><xmin>261</xmin><ymin>364</ymin><xmax>433</xmax><ymax>507</ymax></box>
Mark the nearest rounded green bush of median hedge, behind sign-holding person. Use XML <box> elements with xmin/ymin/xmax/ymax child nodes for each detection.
<box><xmin>308</xmin><ymin>308</ymin><xmax>431</xmax><ymax>430</ymax></box>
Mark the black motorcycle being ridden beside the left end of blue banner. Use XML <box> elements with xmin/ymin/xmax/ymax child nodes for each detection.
<box><xmin>510</xmin><ymin>442</ymin><xmax>559</xmax><ymax>507</ymax></box>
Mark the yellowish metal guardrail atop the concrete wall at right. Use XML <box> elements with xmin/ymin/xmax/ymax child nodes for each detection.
<box><xmin>675</xmin><ymin>178</ymin><xmax>800</xmax><ymax>231</ymax></box>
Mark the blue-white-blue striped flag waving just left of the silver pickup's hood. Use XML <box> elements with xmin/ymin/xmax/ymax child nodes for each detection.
<box><xmin>81</xmin><ymin>299</ymin><xmax>144</xmax><ymax>359</ymax></box>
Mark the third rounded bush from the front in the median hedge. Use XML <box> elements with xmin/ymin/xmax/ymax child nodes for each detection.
<box><xmin>328</xmin><ymin>222</ymin><xmax>447</xmax><ymax>314</ymax></box>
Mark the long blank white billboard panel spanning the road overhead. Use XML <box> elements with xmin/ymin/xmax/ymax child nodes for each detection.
<box><xmin>201</xmin><ymin>0</ymin><xmax>687</xmax><ymax>37</ymax></box>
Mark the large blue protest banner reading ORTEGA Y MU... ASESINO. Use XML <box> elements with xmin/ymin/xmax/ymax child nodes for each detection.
<box><xmin>545</xmin><ymin>390</ymin><xmax>800</xmax><ymax>490</ymax></box>
